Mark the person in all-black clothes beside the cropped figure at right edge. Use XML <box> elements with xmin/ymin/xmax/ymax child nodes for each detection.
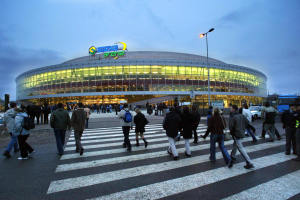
<box><xmin>281</xmin><ymin>105</ymin><xmax>297</xmax><ymax>155</ymax></box>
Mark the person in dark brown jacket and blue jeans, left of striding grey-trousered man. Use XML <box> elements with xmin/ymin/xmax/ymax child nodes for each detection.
<box><xmin>203</xmin><ymin>108</ymin><xmax>231</xmax><ymax>165</ymax></box>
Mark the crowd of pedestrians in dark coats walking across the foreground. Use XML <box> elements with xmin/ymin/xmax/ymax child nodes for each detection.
<box><xmin>3</xmin><ymin>100</ymin><xmax>300</xmax><ymax>169</ymax></box>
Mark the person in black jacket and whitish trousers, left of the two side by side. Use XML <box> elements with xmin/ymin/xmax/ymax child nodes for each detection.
<box><xmin>163</xmin><ymin>107</ymin><xmax>181</xmax><ymax>160</ymax></box>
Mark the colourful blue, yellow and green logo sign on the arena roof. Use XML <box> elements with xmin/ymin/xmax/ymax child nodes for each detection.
<box><xmin>89</xmin><ymin>42</ymin><xmax>127</xmax><ymax>59</ymax></box>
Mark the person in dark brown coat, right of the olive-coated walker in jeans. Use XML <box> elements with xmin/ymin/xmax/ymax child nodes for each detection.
<box><xmin>71</xmin><ymin>103</ymin><xmax>86</xmax><ymax>155</ymax></box>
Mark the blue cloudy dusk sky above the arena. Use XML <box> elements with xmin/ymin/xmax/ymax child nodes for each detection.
<box><xmin>0</xmin><ymin>0</ymin><xmax>300</xmax><ymax>99</ymax></box>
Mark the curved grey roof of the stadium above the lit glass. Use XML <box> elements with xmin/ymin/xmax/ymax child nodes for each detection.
<box><xmin>16</xmin><ymin>51</ymin><xmax>267</xmax><ymax>80</ymax></box>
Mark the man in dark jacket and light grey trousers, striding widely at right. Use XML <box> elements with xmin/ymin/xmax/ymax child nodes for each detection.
<box><xmin>228</xmin><ymin>105</ymin><xmax>254</xmax><ymax>169</ymax></box>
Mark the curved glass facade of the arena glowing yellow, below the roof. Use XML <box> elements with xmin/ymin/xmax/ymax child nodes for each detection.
<box><xmin>16</xmin><ymin>65</ymin><xmax>266</xmax><ymax>100</ymax></box>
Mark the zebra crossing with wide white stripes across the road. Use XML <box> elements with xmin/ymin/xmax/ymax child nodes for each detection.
<box><xmin>47</xmin><ymin>124</ymin><xmax>300</xmax><ymax>200</ymax></box>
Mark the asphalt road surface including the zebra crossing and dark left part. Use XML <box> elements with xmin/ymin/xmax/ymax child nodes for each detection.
<box><xmin>0</xmin><ymin>117</ymin><xmax>300</xmax><ymax>200</ymax></box>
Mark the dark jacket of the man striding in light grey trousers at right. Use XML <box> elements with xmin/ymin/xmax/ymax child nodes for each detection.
<box><xmin>229</xmin><ymin>113</ymin><xmax>249</xmax><ymax>138</ymax></box>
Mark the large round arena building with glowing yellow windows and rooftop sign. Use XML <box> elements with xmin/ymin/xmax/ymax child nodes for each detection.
<box><xmin>16</xmin><ymin>46</ymin><xmax>267</xmax><ymax>107</ymax></box>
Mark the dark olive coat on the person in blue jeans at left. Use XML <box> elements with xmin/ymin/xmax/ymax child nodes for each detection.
<box><xmin>50</xmin><ymin>108</ymin><xmax>71</xmax><ymax>130</ymax></box>
